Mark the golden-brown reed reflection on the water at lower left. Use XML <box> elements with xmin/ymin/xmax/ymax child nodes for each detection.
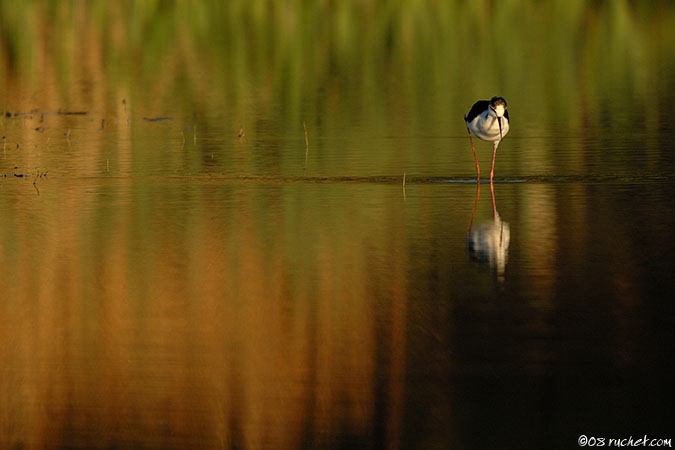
<box><xmin>0</xmin><ymin>175</ymin><xmax>406</xmax><ymax>448</ymax></box>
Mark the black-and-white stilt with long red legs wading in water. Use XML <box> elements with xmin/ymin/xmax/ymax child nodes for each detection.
<box><xmin>464</xmin><ymin>97</ymin><xmax>509</xmax><ymax>182</ymax></box>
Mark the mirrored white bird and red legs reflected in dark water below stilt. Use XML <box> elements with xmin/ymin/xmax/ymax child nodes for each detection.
<box><xmin>466</xmin><ymin>181</ymin><xmax>511</xmax><ymax>281</ymax></box>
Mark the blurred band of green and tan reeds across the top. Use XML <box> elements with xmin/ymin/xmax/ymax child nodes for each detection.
<box><xmin>0</xmin><ymin>0</ymin><xmax>675</xmax><ymax>178</ymax></box>
